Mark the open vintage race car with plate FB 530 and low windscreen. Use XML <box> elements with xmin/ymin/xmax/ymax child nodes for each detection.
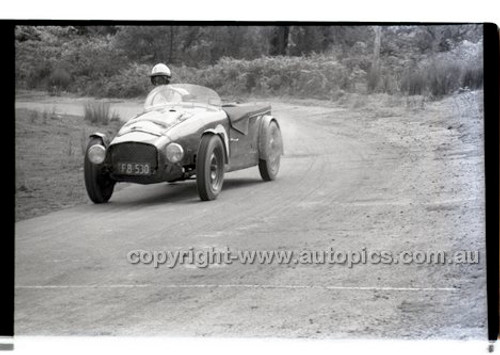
<box><xmin>84</xmin><ymin>84</ymin><xmax>283</xmax><ymax>203</ymax></box>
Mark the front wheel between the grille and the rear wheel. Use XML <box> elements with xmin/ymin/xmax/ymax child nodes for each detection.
<box><xmin>196</xmin><ymin>134</ymin><xmax>224</xmax><ymax>201</ymax></box>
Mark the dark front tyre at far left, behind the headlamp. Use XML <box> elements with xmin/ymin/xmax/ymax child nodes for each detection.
<box><xmin>83</xmin><ymin>138</ymin><xmax>116</xmax><ymax>203</ymax></box>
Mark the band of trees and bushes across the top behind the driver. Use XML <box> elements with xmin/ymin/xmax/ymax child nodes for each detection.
<box><xmin>15</xmin><ymin>25</ymin><xmax>483</xmax><ymax>99</ymax></box>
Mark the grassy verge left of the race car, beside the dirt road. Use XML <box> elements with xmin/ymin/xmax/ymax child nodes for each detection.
<box><xmin>15</xmin><ymin>109</ymin><xmax>121</xmax><ymax>221</ymax></box>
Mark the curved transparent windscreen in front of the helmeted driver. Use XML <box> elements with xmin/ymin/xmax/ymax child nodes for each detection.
<box><xmin>144</xmin><ymin>84</ymin><xmax>221</xmax><ymax>110</ymax></box>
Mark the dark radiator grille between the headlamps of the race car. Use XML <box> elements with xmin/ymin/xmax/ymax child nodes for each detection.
<box><xmin>109</xmin><ymin>143</ymin><xmax>158</xmax><ymax>169</ymax></box>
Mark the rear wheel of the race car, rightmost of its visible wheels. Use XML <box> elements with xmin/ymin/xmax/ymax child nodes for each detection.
<box><xmin>259</xmin><ymin>121</ymin><xmax>283</xmax><ymax>181</ymax></box>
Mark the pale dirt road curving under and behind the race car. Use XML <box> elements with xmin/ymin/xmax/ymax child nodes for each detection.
<box><xmin>15</xmin><ymin>94</ymin><xmax>486</xmax><ymax>339</ymax></box>
